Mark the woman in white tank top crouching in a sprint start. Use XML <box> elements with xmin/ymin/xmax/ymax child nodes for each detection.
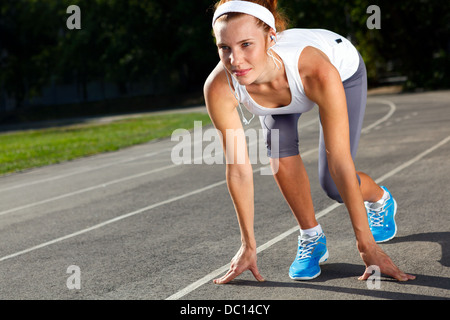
<box><xmin>204</xmin><ymin>0</ymin><xmax>414</xmax><ymax>284</ymax></box>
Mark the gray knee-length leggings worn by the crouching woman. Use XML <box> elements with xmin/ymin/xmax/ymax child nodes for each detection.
<box><xmin>260</xmin><ymin>55</ymin><xmax>367</xmax><ymax>203</ymax></box>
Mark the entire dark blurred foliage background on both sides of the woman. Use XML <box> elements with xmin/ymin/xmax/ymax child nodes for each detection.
<box><xmin>0</xmin><ymin>0</ymin><xmax>450</xmax><ymax>106</ymax></box>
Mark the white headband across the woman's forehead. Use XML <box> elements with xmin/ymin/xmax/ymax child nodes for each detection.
<box><xmin>212</xmin><ymin>0</ymin><xmax>277</xmax><ymax>32</ymax></box>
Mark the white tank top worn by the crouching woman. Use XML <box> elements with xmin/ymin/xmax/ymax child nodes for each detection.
<box><xmin>231</xmin><ymin>29</ymin><xmax>359</xmax><ymax>116</ymax></box>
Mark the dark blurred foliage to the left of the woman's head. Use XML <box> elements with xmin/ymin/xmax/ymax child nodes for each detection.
<box><xmin>0</xmin><ymin>0</ymin><xmax>217</xmax><ymax>106</ymax></box>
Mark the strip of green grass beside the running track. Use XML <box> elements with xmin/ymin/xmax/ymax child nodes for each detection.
<box><xmin>0</xmin><ymin>113</ymin><xmax>211</xmax><ymax>175</ymax></box>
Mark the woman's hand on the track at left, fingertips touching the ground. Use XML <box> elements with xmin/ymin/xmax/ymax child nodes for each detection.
<box><xmin>214</xmin><ymin>245</ymin><xmax>264</xmax><ymax>284</ymax></box>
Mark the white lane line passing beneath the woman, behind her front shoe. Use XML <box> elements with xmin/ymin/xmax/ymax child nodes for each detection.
<box><xmin>166</xmin><ymin>136</ymin><xmax>450</xmax><ymax>300</ymax></box>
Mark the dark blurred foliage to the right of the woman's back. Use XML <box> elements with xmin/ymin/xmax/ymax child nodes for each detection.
<box><xmin>279</xmin><ymin>0</ymin><xmax>450</xmax><ymax>90</ymax></box>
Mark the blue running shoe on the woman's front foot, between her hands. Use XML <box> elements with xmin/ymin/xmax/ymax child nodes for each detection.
<box><xmin>289</xmin><ymin>233</ymin><xmax>328</xmax><ymax>280</ymax></box>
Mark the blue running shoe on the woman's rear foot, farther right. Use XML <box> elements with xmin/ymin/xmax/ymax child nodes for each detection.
<box><xmin>365</xmin><ymin>187</ymin><xmax>397</xmax><ymax>243</ymax></box>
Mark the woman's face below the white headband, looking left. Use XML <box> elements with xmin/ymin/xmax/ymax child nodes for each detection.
<box><xmin>214</xmin><ymin>15</ymin><xmax>268</xmax><ymax>85</ymax></box>
